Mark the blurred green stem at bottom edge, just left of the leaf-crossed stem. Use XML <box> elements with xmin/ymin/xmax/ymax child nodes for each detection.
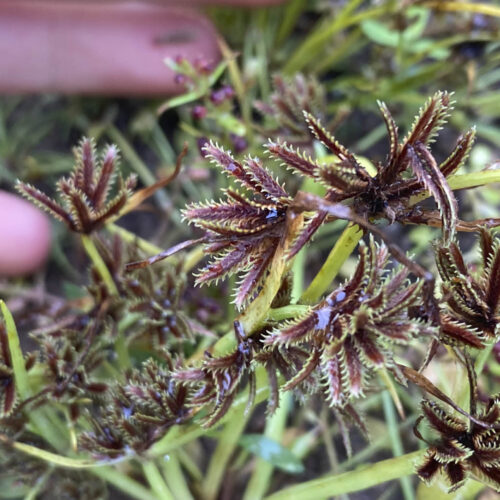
<box><xmin>203</xmin><ymin>407</ymin><xmax>248</xmax><ymax>500</ymax></box>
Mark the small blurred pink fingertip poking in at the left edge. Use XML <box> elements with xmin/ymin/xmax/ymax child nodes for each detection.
<box><xmin>0</xmin><ymin>191</ymin><xmax>51</xmax><ymax>276</ymax></box>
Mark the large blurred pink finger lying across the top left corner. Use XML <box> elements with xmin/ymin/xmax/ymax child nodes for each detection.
<box><xmin>0</xmin><ymin>0</ymin><xmax>219</xmax><ymax>95</ymax></box>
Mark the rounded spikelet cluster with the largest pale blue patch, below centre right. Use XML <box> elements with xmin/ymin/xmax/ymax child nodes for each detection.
<box><xmin>265</xmin><ymin>239</ymin><xmax>430</xmax><ymax>407</ymax></box>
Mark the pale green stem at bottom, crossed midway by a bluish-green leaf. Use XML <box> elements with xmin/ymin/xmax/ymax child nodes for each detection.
<box><xmin>243</xmin><ymin>392</ymin><xmax>292</xmax><ymax>500</ymax></box>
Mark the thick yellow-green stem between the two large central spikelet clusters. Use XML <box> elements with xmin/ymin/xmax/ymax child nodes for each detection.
<box><xmin>300</xmin><ymin>224</ymin><xmax>363</xmax><ymax>304</ymax></box>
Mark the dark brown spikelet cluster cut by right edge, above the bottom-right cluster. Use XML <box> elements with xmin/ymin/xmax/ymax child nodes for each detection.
<box><xmin>436</xmin><ymin>228</ymin><xmax>500</xmax><ymax>349</ymax></box>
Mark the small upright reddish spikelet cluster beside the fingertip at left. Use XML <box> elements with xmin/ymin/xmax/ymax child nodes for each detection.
<box><xmin>16</xmin><ymin>138</ymin><xmax>136</xmax><ymax>234</ymax></box>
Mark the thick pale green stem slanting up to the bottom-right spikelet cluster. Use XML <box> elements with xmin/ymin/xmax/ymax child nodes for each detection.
<box><xmin>266</xmin><ymin>450</ymin><xmax>425</xmax><ymax>500</ymax></box>
